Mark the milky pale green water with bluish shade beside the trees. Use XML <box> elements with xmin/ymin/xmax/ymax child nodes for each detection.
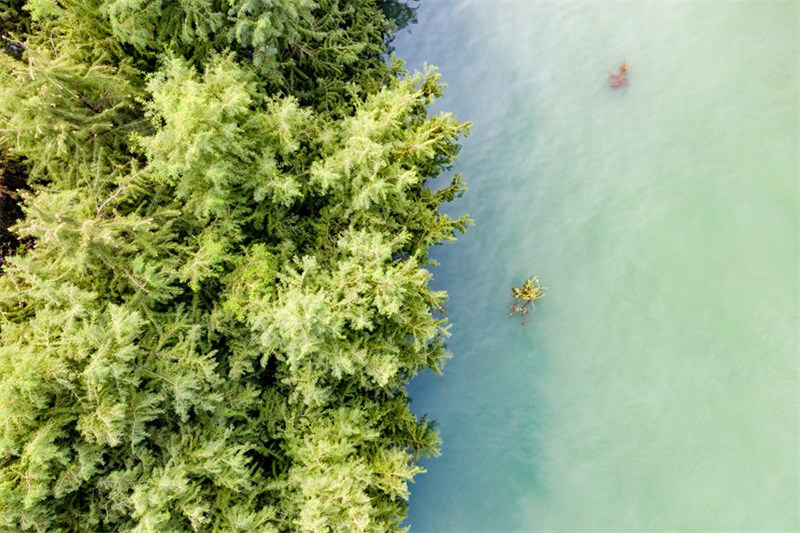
<box><xmin>396</xmin><ymin>0</ymin><xmax>800</xmax><ymax>532</ymax></box>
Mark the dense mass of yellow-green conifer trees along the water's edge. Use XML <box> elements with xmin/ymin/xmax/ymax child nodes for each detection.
<box><xmin>0</xmin><ymin>0</ymin><xmax>469</xmax><ymax>533</ymax></box>
